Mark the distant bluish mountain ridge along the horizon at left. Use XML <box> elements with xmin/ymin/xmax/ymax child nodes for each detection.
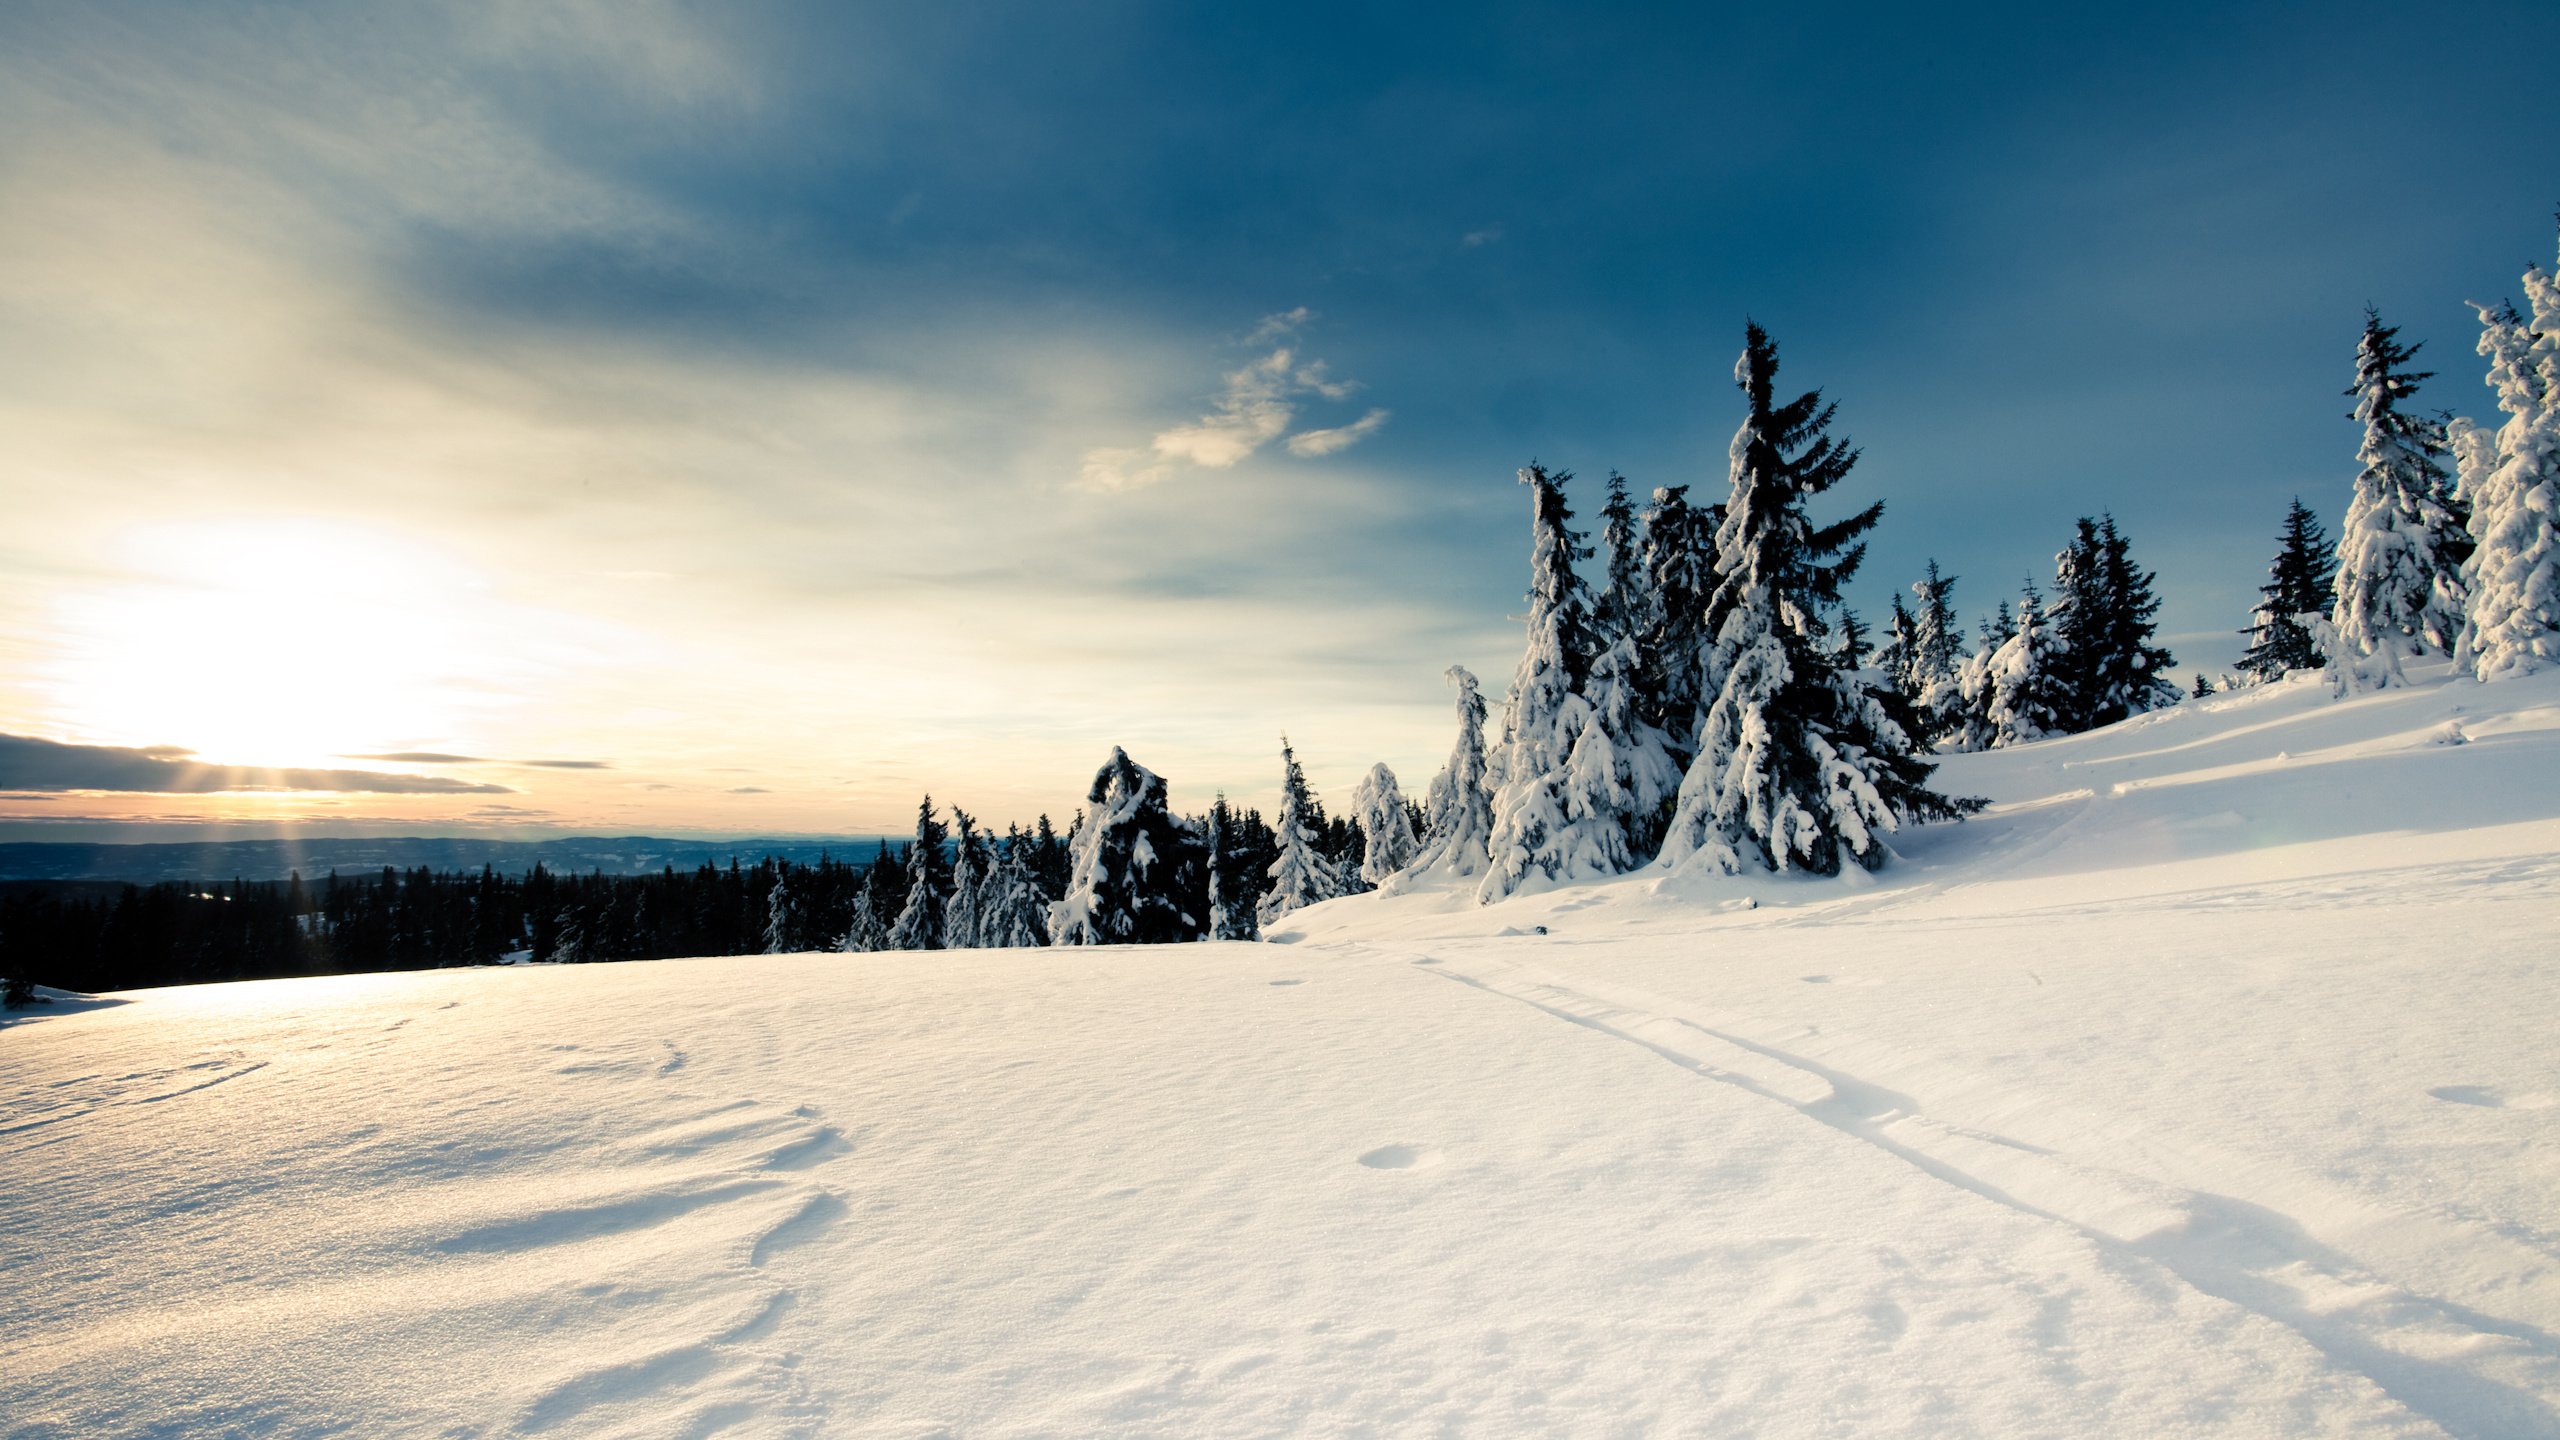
<box><xmin>0</xmin><ymin>835</ymin><xmax>899</xmax><ymax>884</ymax></box>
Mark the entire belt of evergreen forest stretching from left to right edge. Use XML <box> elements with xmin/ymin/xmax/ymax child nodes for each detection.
<box><xmin>0</xmin><ymin>226</ymin><xmax>2560</xmax><ymax>997</ymax></box>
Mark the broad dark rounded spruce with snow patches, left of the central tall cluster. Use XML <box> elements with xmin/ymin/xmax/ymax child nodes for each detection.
<box><xmin>1050</xmin><ymin>746</ymin><xmax>1208</xmax><ymax>945</ymax></box>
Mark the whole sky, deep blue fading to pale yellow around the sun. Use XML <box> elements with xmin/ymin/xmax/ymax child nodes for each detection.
<box><xmin>0</xmin><ymin>5</ymin><xmax>2560</xmax><ymax>833</ymax></box>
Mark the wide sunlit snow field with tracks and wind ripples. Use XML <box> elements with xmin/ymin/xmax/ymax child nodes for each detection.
<box><xmin>0</xmin><ymin>676</ymin><xmax>2560</xmax><ymax>1437</ymax></box>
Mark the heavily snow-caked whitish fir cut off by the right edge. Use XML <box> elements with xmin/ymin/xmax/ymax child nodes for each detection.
<box><xmin>2455</xmin><ymin>254</ymin><xmax>2560</xmax><ymax>679</ymax></box>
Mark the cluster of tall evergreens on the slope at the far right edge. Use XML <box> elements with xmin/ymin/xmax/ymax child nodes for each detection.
<box><xmin>2240</xmin><ymin>225</ymin><xmax>2560</xmax><ymax>687</ymax></box>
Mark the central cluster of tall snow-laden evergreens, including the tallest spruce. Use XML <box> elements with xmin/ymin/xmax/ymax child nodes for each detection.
<box><xmin>1370</xmin><ymin>325</ymin><xmax>1974</xmax><ymax>902</ymax></box>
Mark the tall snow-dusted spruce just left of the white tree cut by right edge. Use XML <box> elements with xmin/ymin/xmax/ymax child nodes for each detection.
<box><xmin>2330</xmin><ymin>307</ymin><xmax>2470</xmax><ymax>687</ymax></box>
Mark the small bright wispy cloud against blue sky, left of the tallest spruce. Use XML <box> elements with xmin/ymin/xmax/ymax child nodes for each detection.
<box><xmin>1083</xmin><ymin>305</ymin><xmax>1388</xmax><ymax>489</ymax></box>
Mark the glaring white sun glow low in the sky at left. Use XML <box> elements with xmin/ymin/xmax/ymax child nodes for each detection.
<box><xmin>54</xmin><ymin>520</ymin><xmax>486</xmax><ymax>766</ymax></box>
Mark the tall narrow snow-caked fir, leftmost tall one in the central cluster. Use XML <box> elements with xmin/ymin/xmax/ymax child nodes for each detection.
<box><xmin>1474</xmin><ymin>464</ymin><xmax>1659</xmax><ymax>896</ymax></box>
